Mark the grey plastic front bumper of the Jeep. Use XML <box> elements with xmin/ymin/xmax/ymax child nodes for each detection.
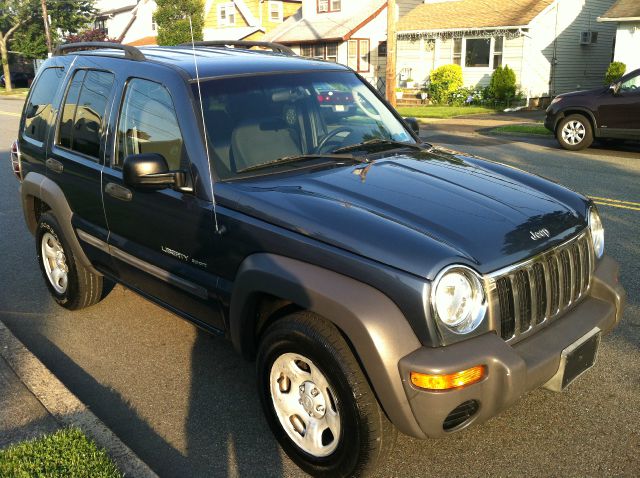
<box><xmin>399</xmin><ymin>256</ymin><xmax>626</xmax><ymax>437</ymax></box>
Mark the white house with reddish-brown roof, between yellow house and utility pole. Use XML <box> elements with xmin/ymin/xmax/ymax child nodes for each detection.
<box><xmin>264</xmin><ymin>0</ymin><xmax>387</xmax><ymax>89</ymax></box>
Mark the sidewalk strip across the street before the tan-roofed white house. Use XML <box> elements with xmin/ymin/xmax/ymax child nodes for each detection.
<box><xmin>419</xmin><ymin>110</ymin><xmax>544</xmax><ymax>134</ymax></box>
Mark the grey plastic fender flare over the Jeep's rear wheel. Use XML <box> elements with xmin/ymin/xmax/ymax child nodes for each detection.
<box><xmin>20</xmin><ymin>171</ymin><xmax>102</xmax><ymax>275</ymax></box>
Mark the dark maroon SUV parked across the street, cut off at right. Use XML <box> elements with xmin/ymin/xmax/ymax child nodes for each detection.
<box><xmin>544</xmin><ymin>70</ymin><xmax>640</xmax><ymax>151</ymax></box>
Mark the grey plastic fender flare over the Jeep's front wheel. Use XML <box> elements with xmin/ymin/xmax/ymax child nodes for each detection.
<box><xmin>229</xmin><ymin>253</ymin><xmax>425</xmax><ymax>438</ymax></box>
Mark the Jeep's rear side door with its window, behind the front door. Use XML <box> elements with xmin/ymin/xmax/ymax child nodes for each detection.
<box><xmin>46</xmin><ymin>69</ymin><xmax>115</xmax><ymax>268</ymax></box>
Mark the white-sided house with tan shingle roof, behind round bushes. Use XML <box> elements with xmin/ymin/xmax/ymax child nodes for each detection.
<box><xmin>397</xmin><ymin>0</ymin><xmax>616</xmax><ymax>98</ymax></box>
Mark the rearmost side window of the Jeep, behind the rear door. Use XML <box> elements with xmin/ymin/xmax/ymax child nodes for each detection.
<box><xmin>22</xmin><ymin>68</ymin><xmax>64</xmax><ymax>143</ymax></box>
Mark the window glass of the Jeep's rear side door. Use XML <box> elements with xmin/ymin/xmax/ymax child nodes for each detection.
<box><xmin>58</xmin><ymin>70</ymin><xmax>114</xmax><ymax>160</ymax></box>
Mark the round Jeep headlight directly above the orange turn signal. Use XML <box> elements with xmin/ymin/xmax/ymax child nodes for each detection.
<box><xmin>431</xmin><ymin>266</ymin><xmax>487</xmax><ymax>334</ymax></box>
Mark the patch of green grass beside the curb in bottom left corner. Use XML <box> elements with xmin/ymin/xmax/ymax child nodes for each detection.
<box><xmin>0</xmin><ymin>428</ymin><xmax>123</xmax><ymax>478</ymax></box>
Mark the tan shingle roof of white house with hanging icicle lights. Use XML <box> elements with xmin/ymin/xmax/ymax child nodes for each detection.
<box><xmin>398</xmin><ymin>0</ymin><xmax>556</xmax><ymax>32</ymax></box>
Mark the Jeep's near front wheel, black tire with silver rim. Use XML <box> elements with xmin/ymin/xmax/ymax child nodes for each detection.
<box><xmin>257</xmin><ymin>312</ymin><xmax>398</xmax><ymax>477</ymax></box>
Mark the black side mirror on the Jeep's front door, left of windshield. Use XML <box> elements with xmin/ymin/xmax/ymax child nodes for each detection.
<box><xmin>122</xmin><ymin>153</ymin><xmax>185</xmax><ymax>191</ymax></box>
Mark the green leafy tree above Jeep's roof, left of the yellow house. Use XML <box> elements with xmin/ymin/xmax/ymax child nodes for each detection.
<box><xmin>153</xmin><ymin>0</ymin><xmax>204</xmax><ymax>45</ymax></box>
